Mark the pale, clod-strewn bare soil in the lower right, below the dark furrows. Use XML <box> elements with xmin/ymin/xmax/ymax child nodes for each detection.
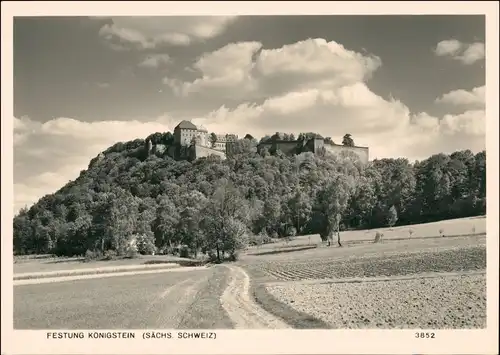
<box><xmin>268</xmin><ymin>274</ymin><xmax>486</xmax><ymax>329</ymax></box>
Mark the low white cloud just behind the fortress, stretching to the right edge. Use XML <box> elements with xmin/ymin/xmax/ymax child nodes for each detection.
<box><xmin>194</xmin><ymin>83</ymin><xmax>485</xmax><ymax>160</ymax></box>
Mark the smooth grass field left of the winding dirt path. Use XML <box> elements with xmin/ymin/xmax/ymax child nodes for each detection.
<box><xmin>14</xmin><ymin>267</ymin><xmax>232</xmax><ymax>329</ymax></box>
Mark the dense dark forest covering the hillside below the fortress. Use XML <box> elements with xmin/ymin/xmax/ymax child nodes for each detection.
<box><xmin>14</xmin><ymin>133</ymin><xmax>486</xmax><ymax>257</ymax></box>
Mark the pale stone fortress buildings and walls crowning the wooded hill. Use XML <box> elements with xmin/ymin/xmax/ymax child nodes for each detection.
<box><xmin>147</xmin><ymin>120</ymin><xmax>369</xmax><ymax>163</ymax></box>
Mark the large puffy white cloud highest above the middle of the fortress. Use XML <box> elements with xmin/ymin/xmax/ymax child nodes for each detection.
<box><xmin>167</xmin><ymin>38</ymin><xmax>381</xmax><ymax>99</ymax></box>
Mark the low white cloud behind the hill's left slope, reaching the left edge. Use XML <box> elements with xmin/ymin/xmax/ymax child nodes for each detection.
<box><xmin>14</xmin><ymin>116</ymin><xmax>177</xmax><ymax>211</ymax></box>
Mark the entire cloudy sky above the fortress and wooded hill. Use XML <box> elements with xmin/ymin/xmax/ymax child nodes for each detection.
<box><xmin>13</xmin><ymin>15</ymin><xmax>486</xmax><ymax>212</ymax></box>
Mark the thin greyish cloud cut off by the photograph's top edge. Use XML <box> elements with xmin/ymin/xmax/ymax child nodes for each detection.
<box><xmin>99</xmin><ymin>16</ymin><xmax>236</xmax><ymax>50</ymax></box>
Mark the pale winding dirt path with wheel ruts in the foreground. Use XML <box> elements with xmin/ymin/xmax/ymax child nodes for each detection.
<box><xmin>220</xmin><ymin>265</ymin><xmax>290</xmax><ymax>329</ymax></box>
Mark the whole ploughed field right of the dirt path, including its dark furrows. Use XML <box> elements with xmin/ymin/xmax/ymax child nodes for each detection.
<box><xmin>241</xmin><ymin>236</ymin><xmax>486</xmax><ymax>329</ymax></box>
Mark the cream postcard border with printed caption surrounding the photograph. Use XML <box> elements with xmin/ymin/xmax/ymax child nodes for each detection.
<box><xmin>1</xmin><ymin>1</ymin><xmax>499</xmax><ymax>354</ymax></box>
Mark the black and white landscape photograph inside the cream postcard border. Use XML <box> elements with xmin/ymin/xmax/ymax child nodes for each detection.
<box><xmin>2</xmin><ymin>2</ymin><xmax>498</xmax><ymax>355</ymax></box>
